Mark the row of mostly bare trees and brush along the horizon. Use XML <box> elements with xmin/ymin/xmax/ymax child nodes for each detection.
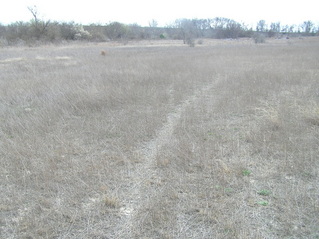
<box><xmin>0</xmin><ymin>8</ymin><xmax>319</xmax><ymax>46</ymax></box>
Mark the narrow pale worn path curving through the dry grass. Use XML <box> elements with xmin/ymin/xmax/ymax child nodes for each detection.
<box><xmin>115</xmin><ymin>79</ymin><xmax>221</xmax><ymax>238</ymax></box>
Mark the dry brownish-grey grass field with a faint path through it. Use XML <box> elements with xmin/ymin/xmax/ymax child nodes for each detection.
<box><xmin>0</xmin><ymin>38</ymin><xmax>319</xmax><ymax>239</ymax></box>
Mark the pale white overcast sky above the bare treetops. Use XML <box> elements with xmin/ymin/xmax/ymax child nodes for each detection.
<box><xmin>0</xmin><ymin>0</ymin><xmax>319</xmax><ymax>26</ymax></box>
